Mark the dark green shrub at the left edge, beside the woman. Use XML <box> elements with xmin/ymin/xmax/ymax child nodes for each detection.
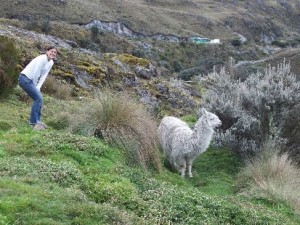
<box><xmin>0</xmin><ymin>36</ymin><xmax>19</xmax><ymax>97</ymax></box>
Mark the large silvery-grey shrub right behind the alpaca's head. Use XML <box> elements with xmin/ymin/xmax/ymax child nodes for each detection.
<box><xmin>202</xmin><ymin>59</ymin><xmax>300</xmax><ymax>157</ymax></box>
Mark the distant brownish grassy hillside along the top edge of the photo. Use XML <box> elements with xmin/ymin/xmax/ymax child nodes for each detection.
<box><xmin>0</xmin><ymin>0</ymin><xmax>300</xmax><ymax>42</ymax></box>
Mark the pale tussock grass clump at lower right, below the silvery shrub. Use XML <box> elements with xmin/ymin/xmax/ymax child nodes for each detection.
<box><xmin>237</xmin><ymin>142</ymin><xmax>300</xmax><ymax>213</ymax></box>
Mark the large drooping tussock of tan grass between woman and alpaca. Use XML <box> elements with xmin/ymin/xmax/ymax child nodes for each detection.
<box><xmin>71</xmin><ymin>93</ymin><xmax>161</xmax><ymax>171</ymax></box>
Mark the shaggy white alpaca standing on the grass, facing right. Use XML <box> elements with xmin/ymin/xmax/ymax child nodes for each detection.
<box><xmin>158</xmin><ymin>108</ymin><xmax>222</xmax><ymax>177</ymax></box>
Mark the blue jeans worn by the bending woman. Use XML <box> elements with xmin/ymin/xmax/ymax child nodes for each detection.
<box><xmin>19</xmin><ymin>74</ymin><xmax>43</xmax><ymax>125</ymax></box>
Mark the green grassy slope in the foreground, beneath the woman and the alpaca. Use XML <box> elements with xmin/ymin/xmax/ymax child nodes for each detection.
<box><xmin>0</xmin><ymin>89</ymin><xmax>300</xmax><ymax>224</ymax></box>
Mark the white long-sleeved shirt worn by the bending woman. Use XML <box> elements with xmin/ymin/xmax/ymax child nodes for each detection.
<box><xmin>21</xmin><ymin>54</ymin><xmax>54</xmax><ymax>90</ymax></box>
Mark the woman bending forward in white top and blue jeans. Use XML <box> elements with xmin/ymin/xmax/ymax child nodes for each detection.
<box><xmin>19</xmin><ymin>46</ymin><xmax>57</xmax><ymax>130</ymax></box>
